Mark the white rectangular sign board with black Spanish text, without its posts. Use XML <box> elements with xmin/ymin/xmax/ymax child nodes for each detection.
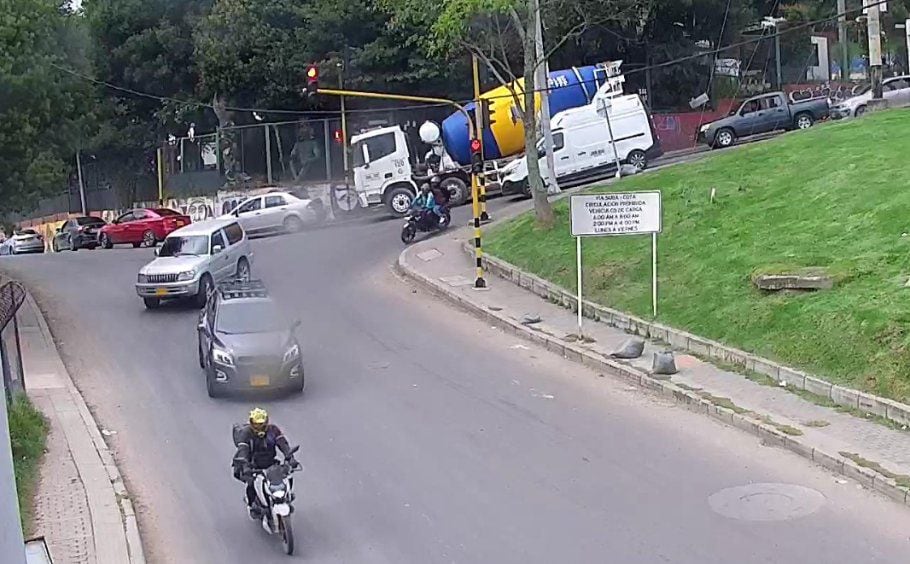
<box><xmin>571</xmin><ymin>191</ymin><xmax>661</xmax><ymax>237</ymax></box>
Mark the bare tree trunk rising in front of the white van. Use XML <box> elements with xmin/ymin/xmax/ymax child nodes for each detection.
<box><xmin>522</xmin><ymin>0</ymin><xmax>554</xmax><ymax>229</ymax></box>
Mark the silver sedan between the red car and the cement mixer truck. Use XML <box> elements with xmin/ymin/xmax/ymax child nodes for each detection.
<box><xmin>226</xmin><ymin>192</ymin><xmax>326</xmax><ymax>235</ymax></box>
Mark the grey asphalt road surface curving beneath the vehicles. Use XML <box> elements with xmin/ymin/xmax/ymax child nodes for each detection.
<box><xmin>0</xmin><ymin>192</ymin><xmax>910</xmax><ymax>564</ymax></box>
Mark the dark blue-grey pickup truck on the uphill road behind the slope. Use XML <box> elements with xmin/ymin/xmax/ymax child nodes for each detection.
<box><xmin>697</xmin><ymin>92</ymin><xmax>829</xmax><ymax>149</ymax></box>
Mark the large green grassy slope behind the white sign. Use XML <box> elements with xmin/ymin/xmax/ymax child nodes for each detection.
<box><xmin>486</xmin><ymin>110</ymin><xmax>910</xmax><ymax>401</ymax></box>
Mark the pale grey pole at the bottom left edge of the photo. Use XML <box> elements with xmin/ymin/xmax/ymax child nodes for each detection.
<box><xmin>0</xmin><ymin>372</ymin><xmax>26</xmax><ymax>564</ymax></box>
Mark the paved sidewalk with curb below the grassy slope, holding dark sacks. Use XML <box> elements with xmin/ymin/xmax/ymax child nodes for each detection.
<box><xmin>398</xmin><ymin>224</ymin><xmax>910</xmax><ymax>505</ymax></box>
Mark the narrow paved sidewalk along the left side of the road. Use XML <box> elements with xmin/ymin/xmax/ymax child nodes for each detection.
<box><xmin>19</xmin><ymin>296</ymin><xmax>145</xmax><ymax>564</ymax></box>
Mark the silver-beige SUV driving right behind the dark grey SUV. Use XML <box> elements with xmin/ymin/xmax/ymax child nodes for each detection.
<box><xmin>136</xmin><ymin>218</ymin><xmax>253</xmax><ymax>309</ymax></box>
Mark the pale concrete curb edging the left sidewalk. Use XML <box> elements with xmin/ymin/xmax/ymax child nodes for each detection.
<box><xmin>25</xmin><ymin>293</ymin><xmax>145</xmax><ymax>564</ymax></box>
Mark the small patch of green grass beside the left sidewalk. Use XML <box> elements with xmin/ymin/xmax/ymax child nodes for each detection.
<box><xmin>8</xmin><ymin>395</ymin><xmax>48</xmax><ymax>534</ymax></box>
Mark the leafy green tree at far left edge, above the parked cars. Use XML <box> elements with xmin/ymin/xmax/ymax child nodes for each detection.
<box><xmin>0</xmin><ymin>0</ymin><xmax>91</xmax><ymax>213</ymax></box>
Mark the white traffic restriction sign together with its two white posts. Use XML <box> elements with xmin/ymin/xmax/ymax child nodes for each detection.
<box><xmin>570</xmin><ymin>191</ymin><xmax>661</xmax><ymax>336</ymax></box>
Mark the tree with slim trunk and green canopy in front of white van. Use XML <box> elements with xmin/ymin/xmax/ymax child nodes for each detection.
<box><xmin>384</xmin><ymin>0</ymin><xmax>644</xmax><ymax>228</ymax></box>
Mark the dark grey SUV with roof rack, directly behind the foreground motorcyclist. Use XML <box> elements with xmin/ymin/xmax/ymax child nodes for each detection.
<box><xmin>197</xmin><ymin>280</ymin><xmax>305</xmax><ymax>397</ymax></box>
